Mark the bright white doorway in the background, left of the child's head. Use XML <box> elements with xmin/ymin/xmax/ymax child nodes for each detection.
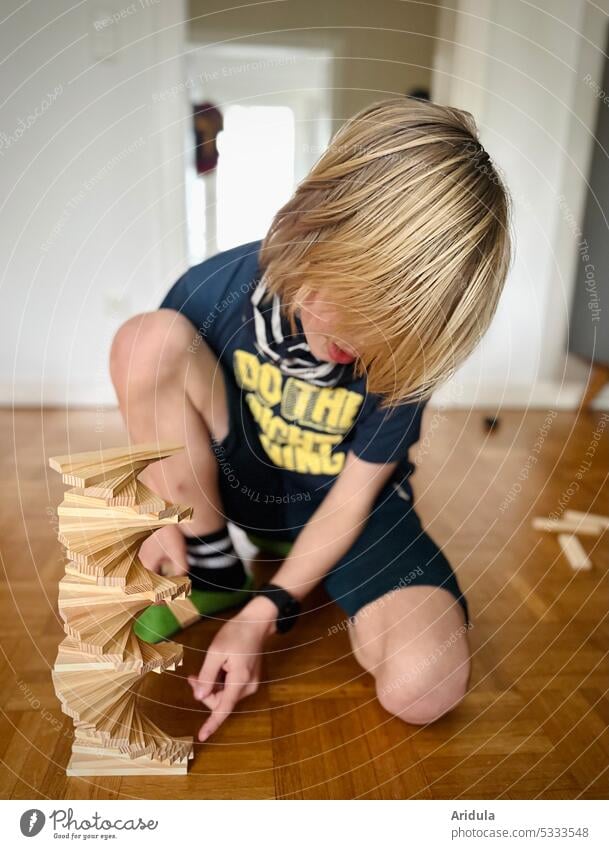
<box><xmin>185</xmin><ymin>43</ymin><xmax>332</xmax><ymax>265</ymax></box>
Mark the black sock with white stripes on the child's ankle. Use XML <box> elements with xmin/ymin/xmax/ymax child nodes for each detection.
<box><xmin>186</xmin><ymin>527</ymin><xmax>247</xmax><ymax>592</ymax></box>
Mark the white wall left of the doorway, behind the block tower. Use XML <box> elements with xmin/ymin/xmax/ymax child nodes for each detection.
<box><xmin>0</xmin><ymin>0</ymin><xmax>186</xmax><ymax>404</ymax></box>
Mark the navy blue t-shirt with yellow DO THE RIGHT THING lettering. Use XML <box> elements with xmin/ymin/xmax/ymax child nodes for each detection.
<box><xmin>161</xmin><ymin>242</ymin><xmax>424</xmax><ymax>492</ymax></box>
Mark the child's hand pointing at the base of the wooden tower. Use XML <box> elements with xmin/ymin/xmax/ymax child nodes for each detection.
<box><xmin>188</xmin><ymin>598</ymin><xmax>277</xmax><ymax>743</ymax></box>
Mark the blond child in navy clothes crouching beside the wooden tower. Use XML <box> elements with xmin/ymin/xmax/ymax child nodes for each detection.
<box><xmin>111</xmin><ymin>98</ymin><xmax>509</xmax><ymax>741</ymax></box>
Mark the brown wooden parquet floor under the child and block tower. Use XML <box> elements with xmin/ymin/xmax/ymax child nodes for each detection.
<box><xmin>0</xmin><ymin>410</ymin><xmax>609</xmax><ymax>799</ymax></box>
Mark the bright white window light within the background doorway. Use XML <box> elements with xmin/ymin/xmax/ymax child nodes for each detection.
<box><xmin>216</xmin><ymin>106</ymin><xmax>294</xmax><ymax>251</ymax></box>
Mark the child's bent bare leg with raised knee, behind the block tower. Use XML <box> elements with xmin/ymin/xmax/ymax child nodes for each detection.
<box><xmin>110</xmin><ymin>310</ymin><xmax>228</xmax><ymax>571</ymax></box>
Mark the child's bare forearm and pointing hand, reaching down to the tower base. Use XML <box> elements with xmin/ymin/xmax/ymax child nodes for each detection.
<box><xmin>189</xmin><ymin>454</ymin><xmax>396</xmax><ymax>741</ymax></box>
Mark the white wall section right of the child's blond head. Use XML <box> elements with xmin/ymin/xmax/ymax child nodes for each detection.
<box><xmin>434</xmin><ymin>0</ymin><xmax>608</xmax><ymax>406</ymax></box>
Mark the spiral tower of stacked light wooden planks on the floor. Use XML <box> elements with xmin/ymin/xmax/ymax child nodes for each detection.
<box><xmin>49</xmin><ymin>445</ymin><xmax>192</xmax><ymax>776</ymax></box>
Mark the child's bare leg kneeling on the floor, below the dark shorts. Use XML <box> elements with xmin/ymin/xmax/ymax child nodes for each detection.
<box><xmin>351</xmin><ymin>586</ymin><xmax>470</xmax><ymax>725</ymax></box>
